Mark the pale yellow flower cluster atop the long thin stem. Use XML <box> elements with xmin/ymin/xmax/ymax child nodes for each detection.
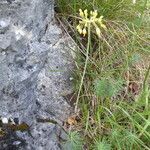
<box><xmin>76</xmin><ymin>9</ymin><xmax>106</xmax><ymax>37</ymax></box>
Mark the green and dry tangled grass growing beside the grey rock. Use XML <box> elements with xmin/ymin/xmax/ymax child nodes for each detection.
<box><xmin>56</xmin><ymin>0</ymin><xmax>150</xmax><ymax>150</ymax></box>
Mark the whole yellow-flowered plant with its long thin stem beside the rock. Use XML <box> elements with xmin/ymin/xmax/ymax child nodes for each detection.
<box><xmin>75</xmin><ymin>9</ymin><xmax>106</xmax><ymax>112</ymax></box>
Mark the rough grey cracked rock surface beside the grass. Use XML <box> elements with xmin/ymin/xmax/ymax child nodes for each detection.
<box><xmin>0</xmin><ymin>0</ymin><xmax>73</xmax><ymax>150</ymax></box>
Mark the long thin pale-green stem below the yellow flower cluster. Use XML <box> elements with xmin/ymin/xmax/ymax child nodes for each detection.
<box><xmin>75</xmin><ymin>24</ymin><xmax>91</xmax><ymax>113</ymax></box>
